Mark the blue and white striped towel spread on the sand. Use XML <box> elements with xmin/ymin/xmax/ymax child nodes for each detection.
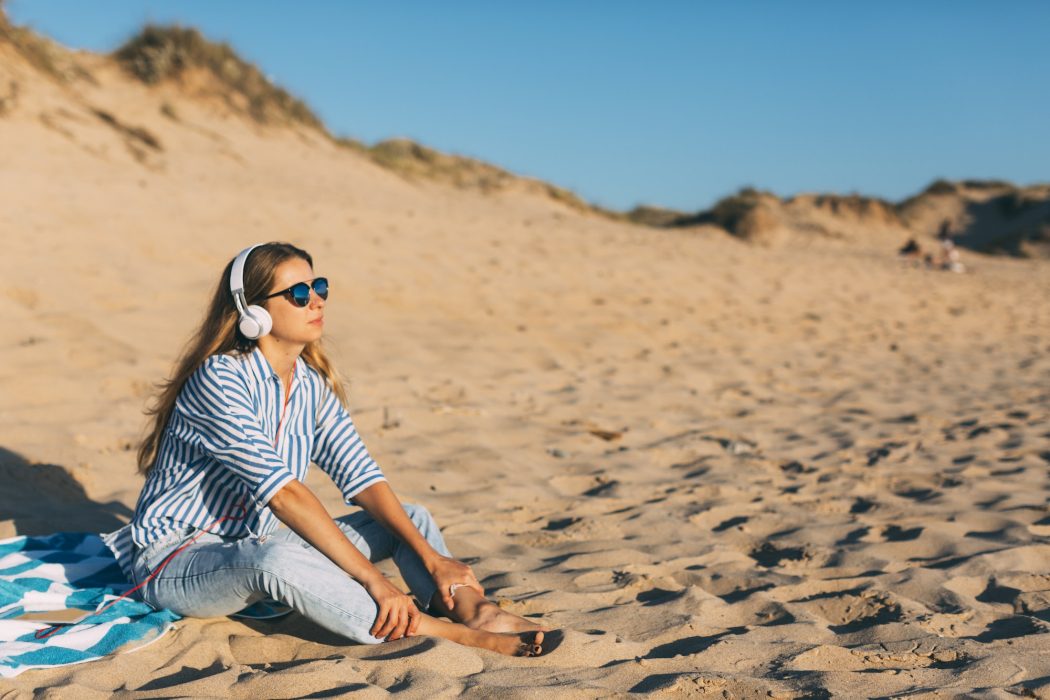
<box><xmin>0</xmin><ymin>528</ymin><xmax>179</xmax><ymax>678</ymax></box>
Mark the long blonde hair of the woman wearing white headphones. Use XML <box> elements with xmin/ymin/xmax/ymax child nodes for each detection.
<box><xmin>138</xmin><ymin>242</ymin><xmax>348</xmax><ymax>474</ymax></box>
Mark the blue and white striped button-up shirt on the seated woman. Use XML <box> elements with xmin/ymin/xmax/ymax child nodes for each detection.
<box><xmin>107</xmin><ymin>346</ymin><xmax>385</xmax><ymax>566</ymax></box>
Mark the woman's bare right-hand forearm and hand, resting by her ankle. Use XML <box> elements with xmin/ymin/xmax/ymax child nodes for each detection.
<box><xmin>354</xmin><ymin>482</ymin><xmax>485</xmax><ymax>610</ymax></box>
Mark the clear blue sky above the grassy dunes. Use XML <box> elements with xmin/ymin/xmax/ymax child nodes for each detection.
<box><xmin>7</xmin><ymin>0</ymin><xmax>1050</xmax><ymax>211</ymax></box>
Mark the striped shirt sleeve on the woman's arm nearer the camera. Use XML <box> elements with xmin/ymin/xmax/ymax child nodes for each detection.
<box><xmin>175</xmin><ymin>356</ymin><xmax>295</xmax><ymax>506</ymax></box>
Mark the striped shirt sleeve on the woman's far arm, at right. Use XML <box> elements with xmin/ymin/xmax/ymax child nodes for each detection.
<box><xmin>311</xmin><ymin>385</ymin><xmax>386</xmax><ymax>504</ymax></box>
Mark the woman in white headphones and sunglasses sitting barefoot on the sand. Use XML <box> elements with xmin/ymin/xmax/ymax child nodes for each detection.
<box><xmin>119</xmin><ymin>242</ymin><xmax>544</xmax><ymax>656</ymax></box>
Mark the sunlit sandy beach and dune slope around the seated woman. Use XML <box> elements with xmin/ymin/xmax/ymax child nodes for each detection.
<box><xmin>0</xmin><ymin>41</ymin><xmax>1050</xmax><ymax>698</ymax></box>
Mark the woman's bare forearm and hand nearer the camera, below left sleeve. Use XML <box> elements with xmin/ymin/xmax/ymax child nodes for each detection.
<box><xmin>269</xmin><ymin>481</ymin><xmax>425</xmax><ymax>641</ymax></box>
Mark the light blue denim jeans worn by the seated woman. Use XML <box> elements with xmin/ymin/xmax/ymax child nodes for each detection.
<box><xmin>132</xmin><ymin>504</ymin><xmax>450</xmax><ymax>643</ymax></box>
